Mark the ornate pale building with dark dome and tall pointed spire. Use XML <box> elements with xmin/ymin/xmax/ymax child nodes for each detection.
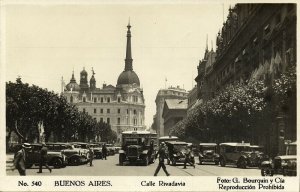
<box><xmin>63</xmin><ymin>24</ymin><xmax>146</xmax><ymax>140</ymax></box>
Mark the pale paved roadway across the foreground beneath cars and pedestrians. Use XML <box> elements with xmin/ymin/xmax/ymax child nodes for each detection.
<box><xmin>6</xmin><ymin>154</ymin><xmax>260</xmax><ymax>176</ymax></box>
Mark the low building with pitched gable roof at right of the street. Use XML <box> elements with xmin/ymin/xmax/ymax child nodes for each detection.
<box><xmin>162</xmin><ymin>99</ymin><xmax>188</xmax><ymax>136</ymax></box>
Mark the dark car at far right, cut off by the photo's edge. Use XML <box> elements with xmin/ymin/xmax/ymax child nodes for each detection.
<box><xmin>261</xmin><ymin>142</ymin><xmax>297</xmax><ymax>176</ymax></box>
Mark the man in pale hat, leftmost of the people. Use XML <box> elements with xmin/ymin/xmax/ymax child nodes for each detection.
<box><xmin>13</xmin><ymin>143</ymin><xmax>31</xmax><ymax>176</ymax></box>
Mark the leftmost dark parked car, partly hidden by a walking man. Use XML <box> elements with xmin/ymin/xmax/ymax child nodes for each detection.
<box><xmin>25</xmin><ymin>144</ymin><xmax>67</xmax><ymax>168</ymax></box>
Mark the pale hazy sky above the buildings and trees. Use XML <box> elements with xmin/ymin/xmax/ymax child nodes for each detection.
<box><xmin>2</xmin><ymin>1</ymin><xmax>229</xmax><ymax>127</ymax></box>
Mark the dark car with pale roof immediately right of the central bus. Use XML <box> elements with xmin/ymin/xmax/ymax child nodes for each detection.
<box><xmin>165</xmin><ymin>141</ymin><xmax>195</xmax><ymax>166</ymax></box>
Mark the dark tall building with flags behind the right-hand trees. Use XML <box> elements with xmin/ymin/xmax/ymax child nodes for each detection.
<box><xmin>195</xmin><ymin>4</ymin><xmax>297</xmax><ymax>154</ymax></box>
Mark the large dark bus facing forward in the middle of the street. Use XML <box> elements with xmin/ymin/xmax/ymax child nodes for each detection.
<box><xmin>119</xmin><ymin>131</ymin><xmax>157</xmax><ymax>166</ymax></box>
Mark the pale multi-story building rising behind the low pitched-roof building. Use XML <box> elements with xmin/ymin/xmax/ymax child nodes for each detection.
<box><xmin>153</xmin><ymin>86</ymin><xmax>188</xmax><ymax>137</ymax></box>
